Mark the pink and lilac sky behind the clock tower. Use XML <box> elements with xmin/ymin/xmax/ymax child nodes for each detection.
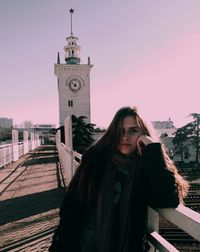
<box><xmin>0</xmin><ymin>0</ymin><xmax>200</xmax><ymax>128</ymax></box>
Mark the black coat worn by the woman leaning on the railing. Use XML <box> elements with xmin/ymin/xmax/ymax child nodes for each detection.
<box><xmin>49</xmin><ymin>143</ymin><xmax>179</xmax><ymax>252</ymax></box>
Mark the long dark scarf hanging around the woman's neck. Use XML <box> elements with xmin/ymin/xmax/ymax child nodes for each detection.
<box><xmin>97</xmin><ymin>153</ymin><xmax>145</xmax><ymax>252</ymax></box>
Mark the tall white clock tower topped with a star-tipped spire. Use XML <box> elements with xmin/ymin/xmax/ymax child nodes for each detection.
<box><xmin>54</xmin><ymin>9</ymin><xmax>93</xmax><ymax>126</ymax></box>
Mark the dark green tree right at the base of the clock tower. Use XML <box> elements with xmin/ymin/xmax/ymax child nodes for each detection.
<box><xmin>72</xmin><ymin>115</ymin><xmax>95</xmax><ymax>154</ymax></box>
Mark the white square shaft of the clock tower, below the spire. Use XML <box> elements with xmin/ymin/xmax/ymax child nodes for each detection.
<box><xmin>55</xmin><ymin>64</ymin><xmax>92</xmax><ymax>125</ymax></box>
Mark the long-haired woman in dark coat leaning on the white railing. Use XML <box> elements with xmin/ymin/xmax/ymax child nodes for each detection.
<box><xmin>49</xmin><ymin>107</ymin><xmax>188</xmax><ymax>252</ymax></box>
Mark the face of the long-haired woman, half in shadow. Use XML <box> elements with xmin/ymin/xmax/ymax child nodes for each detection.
<box><xmin>118</xmin><ymin>116</ymin><xmax>143</xmax><ymax>155</ymax></box>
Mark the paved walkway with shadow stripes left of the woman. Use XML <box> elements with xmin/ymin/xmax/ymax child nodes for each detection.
<box><xmin>0</xmin><ymin>145</ymin><xmax>65</xmax><ymax>252</ymax></box>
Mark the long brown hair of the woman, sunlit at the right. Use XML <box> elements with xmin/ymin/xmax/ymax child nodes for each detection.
<box><xmin>72</xmin><ymin>107</ymin><xmax>188</xmax><ymax>205</ymax></box>
